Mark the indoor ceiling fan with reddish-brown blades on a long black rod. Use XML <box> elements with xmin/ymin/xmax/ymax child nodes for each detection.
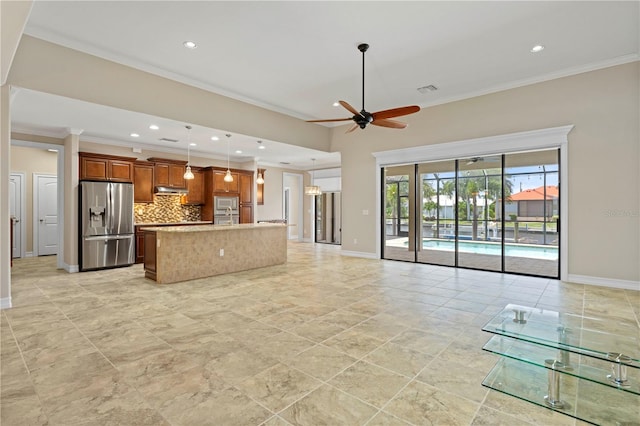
<box><xmin>307</xmin><ymin>43</ymin><xmax>420</xmax><ymax>133</ymax></box>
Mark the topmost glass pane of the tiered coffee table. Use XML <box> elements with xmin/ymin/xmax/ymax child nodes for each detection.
<box><xmin>482</xmin><ymin>304</ymin><xmax>640</xmax><ymax>368</ymax></box>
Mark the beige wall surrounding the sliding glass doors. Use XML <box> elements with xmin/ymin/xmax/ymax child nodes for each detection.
<box><xmin>332</xmin><ymin>62</ymin><xmax>640</xmax><ymax>282</ymax></box>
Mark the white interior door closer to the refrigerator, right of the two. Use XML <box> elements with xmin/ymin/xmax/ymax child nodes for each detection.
<box><xmin>33</xmin><ymin>174</ymin><xmax>58</xmax><ymax>256</ymax></box>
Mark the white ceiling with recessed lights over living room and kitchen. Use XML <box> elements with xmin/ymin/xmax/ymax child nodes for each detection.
<box><xmin>7</xmin><ymin>1</ymin><xmax>640</xmax><ymax>169</ymax></box>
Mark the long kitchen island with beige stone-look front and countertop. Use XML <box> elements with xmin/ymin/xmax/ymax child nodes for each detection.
<box><xmin>142</xmin><ymin>223</ymin><xmax>287</xmax><ymax>284</ymax></box>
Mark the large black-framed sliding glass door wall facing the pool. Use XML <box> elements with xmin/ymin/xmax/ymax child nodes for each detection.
<box><xmin>383</xmin><ymin>149</ymin><xmax>560</xmax><ymax>278</ymax></box>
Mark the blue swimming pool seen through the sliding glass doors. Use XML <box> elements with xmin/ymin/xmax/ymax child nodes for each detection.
<box><xmin>422</xmin><ymin>238</ymin><xmax>558</xmax><ymax>260</ymax></box>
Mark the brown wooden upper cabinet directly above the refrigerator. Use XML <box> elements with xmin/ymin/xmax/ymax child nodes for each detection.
<box><xmin>78</xmin><ymin>152</ymin><xmax>136</xmax><ymax>182</ymax></box>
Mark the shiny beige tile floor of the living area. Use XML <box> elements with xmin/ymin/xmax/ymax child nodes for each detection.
<box><xmin>0</xmin><ymin>243</ymin><xmax>640</xmax><ymax>426</ymax></box>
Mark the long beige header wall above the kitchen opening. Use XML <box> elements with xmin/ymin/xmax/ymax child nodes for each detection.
<box><xmin>7</xmin><ymin>35</ymin><xmax>330</xmax><ymax>151</ymax></box>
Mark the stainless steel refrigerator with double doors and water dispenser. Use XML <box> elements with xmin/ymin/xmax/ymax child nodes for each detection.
<box><xmin>78</xmin><ymin>181</ymin><xmax>135</xmax><ymax>271</ymax></box>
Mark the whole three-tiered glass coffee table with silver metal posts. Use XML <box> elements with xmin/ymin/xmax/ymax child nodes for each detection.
<box><xmin>482</xmin><ymin>304</ymin><xmax>640</xmax><ymax>425</ymax></box>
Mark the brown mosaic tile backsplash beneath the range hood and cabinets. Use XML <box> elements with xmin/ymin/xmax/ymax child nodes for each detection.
<box><xmin>133</xmin><ymin>195</ymin><xmax>200</xmax><ymax>223</ymax></box>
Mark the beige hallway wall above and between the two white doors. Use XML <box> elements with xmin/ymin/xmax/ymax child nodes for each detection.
<box><xmin>11</xmin><ymin>145</ymin><xmax>58</xmax><ymax>253</ymax></box>
